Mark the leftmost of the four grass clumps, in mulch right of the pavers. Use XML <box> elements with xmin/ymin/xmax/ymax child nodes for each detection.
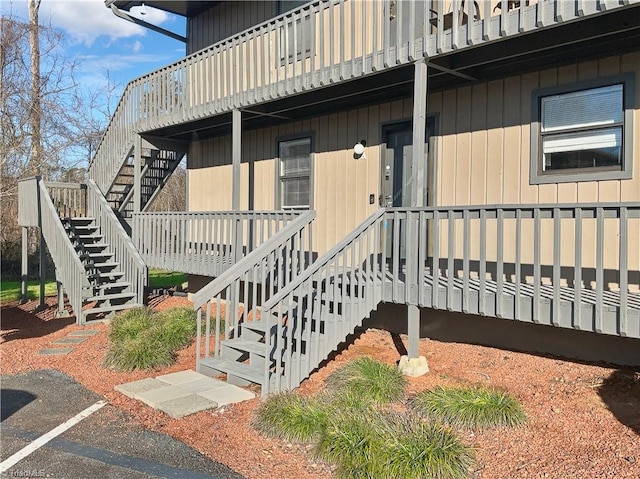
<box><xmin>253</xmin><ymin>392</ymin><xmax>327</xmax><ymax>442</ymax></box>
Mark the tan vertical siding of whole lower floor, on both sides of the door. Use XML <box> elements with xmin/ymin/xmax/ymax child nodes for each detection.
<box><xmin>189</xmin><ymin>54</ymin><xmax>640</xmax><ymax>281</ymax></box>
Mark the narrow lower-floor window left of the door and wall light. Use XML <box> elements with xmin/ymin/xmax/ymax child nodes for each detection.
<box><xmin>278</xmin><ymin>137</ymin><xmax>311</xmax><ymax>208</ymax></box>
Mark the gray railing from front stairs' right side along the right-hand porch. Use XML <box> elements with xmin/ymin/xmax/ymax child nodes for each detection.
<box><xmin>261</xmin><ymin>202</ymin><xmax>640</xmax><ymax>395</ymax></box>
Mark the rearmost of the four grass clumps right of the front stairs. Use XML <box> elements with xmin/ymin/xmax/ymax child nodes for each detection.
<box><xmin>327</xmin><ymin>356</ymin><xmax>406</xmax><ymax>404</ymax></box>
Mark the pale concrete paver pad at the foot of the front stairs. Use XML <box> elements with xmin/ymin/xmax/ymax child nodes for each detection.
<box><xmin>115</xmin><ymin>371</ymin><xmax>255</xmax><ymax>418</ymax></box>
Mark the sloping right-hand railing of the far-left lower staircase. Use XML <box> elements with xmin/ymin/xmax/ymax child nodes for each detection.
<box><xmin>87</xmin><ymin>179</ymin><xmax>148</xmax><ymax>304</ymax></box>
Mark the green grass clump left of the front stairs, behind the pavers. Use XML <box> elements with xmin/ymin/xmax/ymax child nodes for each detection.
<box><xmin>105</xmin><ymin>307</ymin><xmax>197</xmax><ymax>371</ymax></box>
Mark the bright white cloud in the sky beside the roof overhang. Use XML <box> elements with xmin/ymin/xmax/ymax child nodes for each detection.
<box><xmin>40</xmin><ymin>0</ymin><xmax>171</xmax><ymax>46</ymax></box>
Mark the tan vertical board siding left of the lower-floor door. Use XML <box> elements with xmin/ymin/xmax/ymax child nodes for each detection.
<box><xmin>188</xmin><ymin>99</ymin><xmax>412</xmax><ymax>253</ymax></box>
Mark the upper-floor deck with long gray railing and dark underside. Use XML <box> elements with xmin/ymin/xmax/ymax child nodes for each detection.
<box><xmin>90</xmin><ymin>0</ymin><xmax>640</xmax><ymax>193</ymax></box>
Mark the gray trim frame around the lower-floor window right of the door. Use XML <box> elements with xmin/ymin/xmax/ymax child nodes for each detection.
<box><xmin>529</xmin><ymin>73</ymin><xmax>635</xmax><ymax>185</ymax></box>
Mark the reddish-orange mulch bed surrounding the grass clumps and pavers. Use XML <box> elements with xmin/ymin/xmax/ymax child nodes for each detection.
<box><xmin>0</xmin><ymin>297</ymin><xmax>640</xmax><ymax>479</ymax></box>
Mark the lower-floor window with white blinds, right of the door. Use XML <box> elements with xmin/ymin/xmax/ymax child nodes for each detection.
<box><xmin>531</xmin><ymin>74</ymin><xmax>632</xmax><ymax>183</ymax></box>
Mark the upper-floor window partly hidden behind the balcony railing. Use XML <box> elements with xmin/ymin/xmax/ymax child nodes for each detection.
<box><xmin>278</xmin><ymin>0</ymin><xmax>313</xmax><ymax>64</ymax></box>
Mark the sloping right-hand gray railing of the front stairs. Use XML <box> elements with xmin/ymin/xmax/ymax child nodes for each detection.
<box><xmin>261</xmin><ymin>208</ymin><xmax>386</xmax><ymax>397</ymax></box>
